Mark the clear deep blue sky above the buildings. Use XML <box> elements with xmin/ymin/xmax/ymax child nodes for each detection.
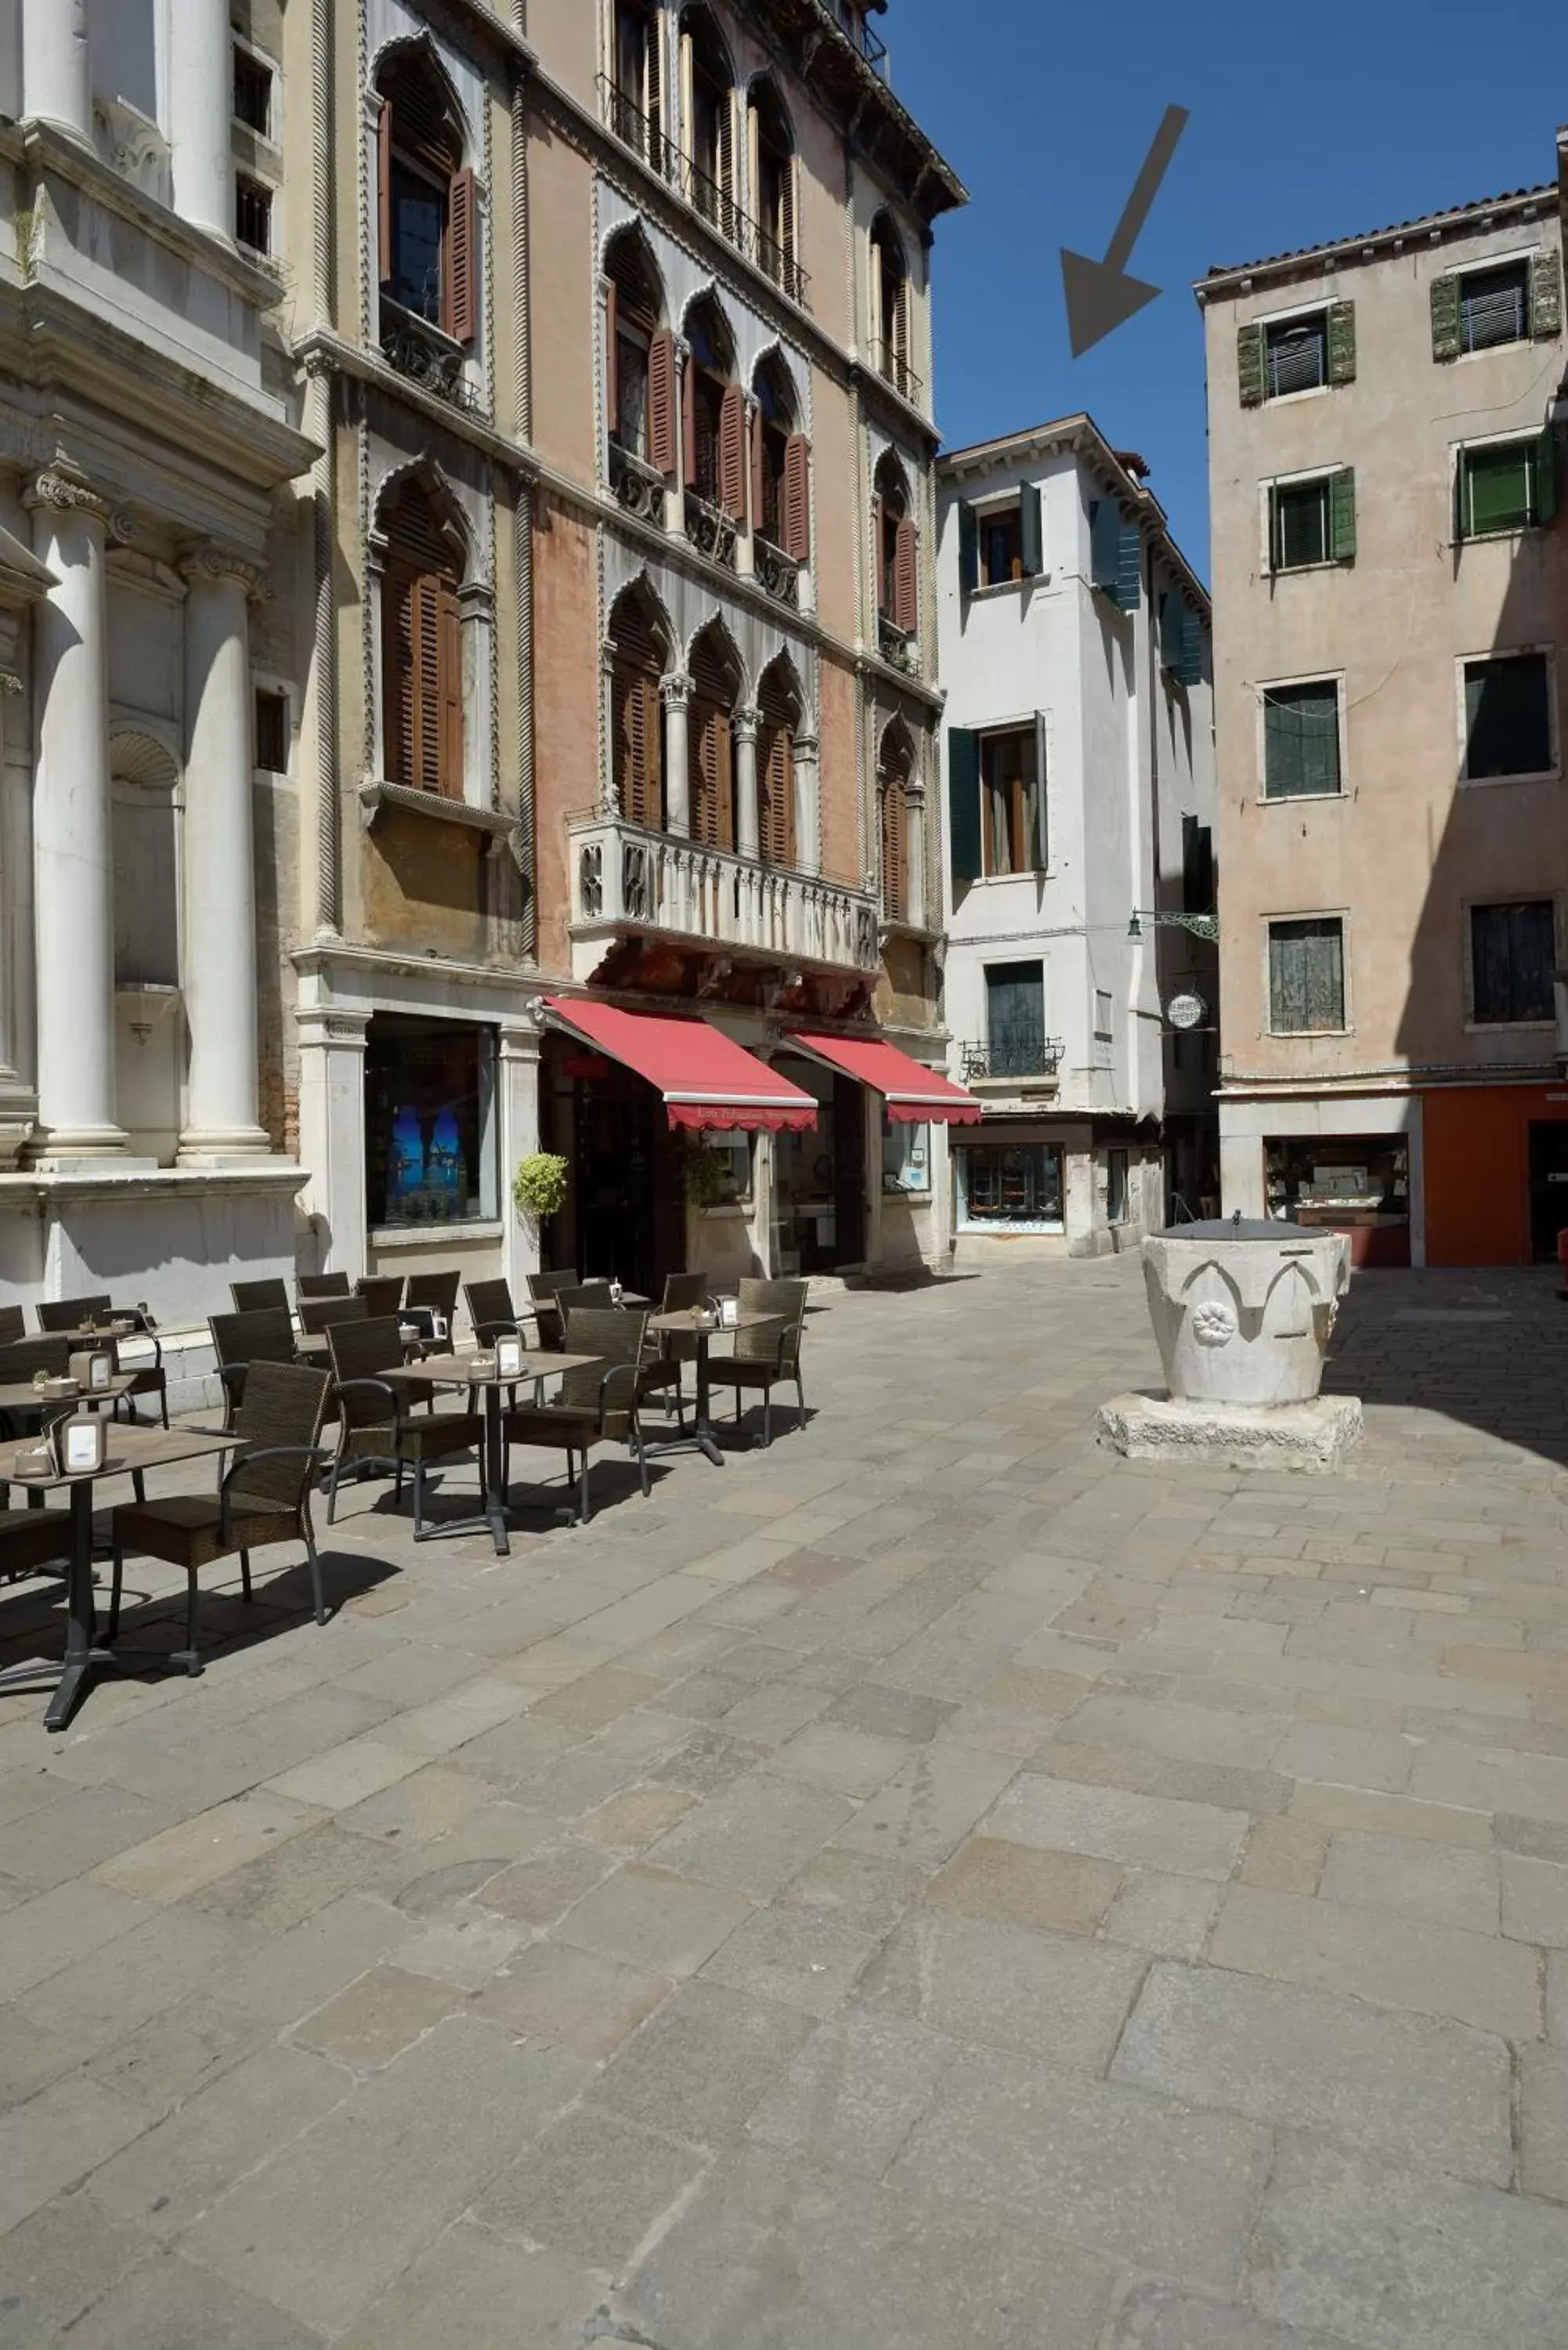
<box><xmin>888</xmin><ymin>0</ymin><xmax>1568</xmax><ymax>578</ymax></box>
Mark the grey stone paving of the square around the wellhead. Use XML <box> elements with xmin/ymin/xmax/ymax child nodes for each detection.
<box><xmin>0</xmin><ymin>1260</ymin><xmax>1568</xmax><ymax>2350</ymax></box>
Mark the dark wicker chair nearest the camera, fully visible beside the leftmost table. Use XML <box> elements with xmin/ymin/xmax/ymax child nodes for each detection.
<box><xmin>108</xmin><ymin>1363</ymin><xmax>331</xmax><ymax>1673</ymax></box>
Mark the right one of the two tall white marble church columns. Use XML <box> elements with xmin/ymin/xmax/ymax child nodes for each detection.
<box><xmin>179</xmin><ymin>548</ymin><xmax>270</xmax><ymax>1166</ymax></box>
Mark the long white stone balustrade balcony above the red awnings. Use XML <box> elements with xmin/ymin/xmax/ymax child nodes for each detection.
<box><xmin>566</xmin><ymin>808</ymin><xmax>880</xmax><ymax>982</ymax></box>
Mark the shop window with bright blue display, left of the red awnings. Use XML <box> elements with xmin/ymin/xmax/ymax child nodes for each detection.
<box><xmin>364</xmin><ymin>1013</ymin><xmax>498</xmax><ymax>1227</ymax></box>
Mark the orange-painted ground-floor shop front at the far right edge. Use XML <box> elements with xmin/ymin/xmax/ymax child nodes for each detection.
<box><xmin>1422</xmin><ymin>1083</ymin><xmax>1568</xmax><ymax>1264</ymax></box>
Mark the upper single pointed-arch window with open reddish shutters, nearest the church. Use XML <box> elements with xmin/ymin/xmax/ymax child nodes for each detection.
<box><xmin>376</xmin><ymin>54</ymin><xmax>479</xmax><ymax>343</ymax></box>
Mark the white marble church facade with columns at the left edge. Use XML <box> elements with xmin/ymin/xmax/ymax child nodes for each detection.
<box><xmin>0</xmin><ymin>0</ymin><xmax>315</xmax><ymax>1323</ymax></box>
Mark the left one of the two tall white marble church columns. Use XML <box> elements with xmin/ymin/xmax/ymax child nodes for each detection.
<box><xmin>23</xmin><ymin>463</ymin><xmax>127</xmax><ymax>1163</ymax></box>
